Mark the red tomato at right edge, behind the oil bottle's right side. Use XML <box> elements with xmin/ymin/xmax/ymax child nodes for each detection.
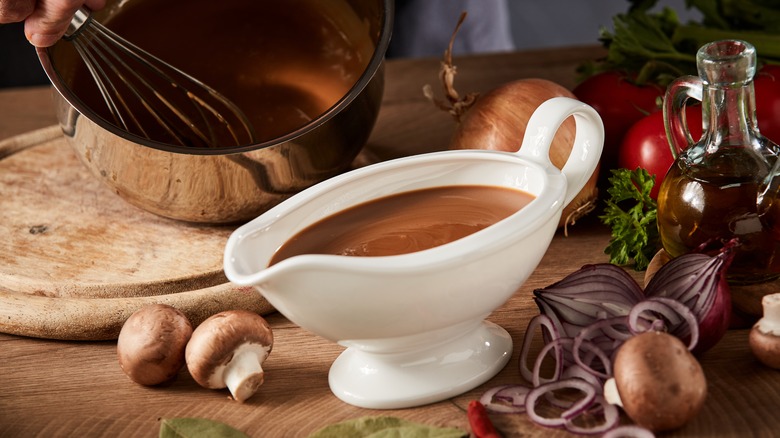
<box><xmin>753</xmin><ymin>64</ymin><xmax>780</xmax><ymax>143</ymax></box>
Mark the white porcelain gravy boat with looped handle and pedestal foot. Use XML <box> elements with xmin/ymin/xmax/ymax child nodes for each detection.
<box><xmin>224</xmin><ymin>97</ymin><xmax>604</xmax><ymax>409</ymax></box>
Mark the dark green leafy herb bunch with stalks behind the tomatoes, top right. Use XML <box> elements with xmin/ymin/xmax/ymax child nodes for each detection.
<box><xmin>578</xmin><ymin>0</ymin><xmax>780</xmax><ymax>86</ymax></box>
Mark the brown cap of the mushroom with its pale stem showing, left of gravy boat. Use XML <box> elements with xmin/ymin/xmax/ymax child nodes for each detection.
<box><xmin>185</xmin><ymin>310</ymin><xmax>274</xmax><ymax>389</ymax></box>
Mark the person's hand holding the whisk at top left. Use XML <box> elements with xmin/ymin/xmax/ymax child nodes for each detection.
<box><xmin>0</xmin><ymin>0</ymin><xmax>106</xmax><ymax>47</ymax></box>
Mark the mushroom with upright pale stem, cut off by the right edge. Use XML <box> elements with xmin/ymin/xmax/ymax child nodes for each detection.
<box><xmin>748</xmin><ymin>293</ymin><xmax>780</xmax><ymax>369</ymax></box>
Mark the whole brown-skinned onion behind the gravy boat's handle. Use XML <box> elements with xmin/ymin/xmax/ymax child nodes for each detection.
<box><xmin>450</xmin><ymin>78</ymin><xmax>599</xmax><ymax>227</ymax></box>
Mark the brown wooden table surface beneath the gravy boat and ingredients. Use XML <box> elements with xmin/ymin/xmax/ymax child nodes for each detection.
<box><xmin>0</xmin><ymin>47</ymin><xmax>780</xmax><ymax>437</ymax></box>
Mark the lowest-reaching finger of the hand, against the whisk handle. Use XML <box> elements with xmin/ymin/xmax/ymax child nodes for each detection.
<box><xmin>23</xmin><ymin>0</ymin><xmax>84</xmax><ymax>47</ymax></box>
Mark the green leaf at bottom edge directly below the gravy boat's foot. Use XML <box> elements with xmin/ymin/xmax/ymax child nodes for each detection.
<box><xmin>309</xmin><ymin>416</ymin><xmax>468</xmax><ymax>438</ymax></box>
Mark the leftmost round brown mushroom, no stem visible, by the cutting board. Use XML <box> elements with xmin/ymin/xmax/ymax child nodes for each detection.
<box><xmin>117</xmin><ymin>304</ymin><xmax>192</xmax><ymax>386</ymax></box>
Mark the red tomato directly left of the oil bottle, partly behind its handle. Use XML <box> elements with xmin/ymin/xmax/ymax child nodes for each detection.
<box><xmin>618</xmin><ymin>106</ymin><xmax>702</xmax><ymax>199</ymax></box>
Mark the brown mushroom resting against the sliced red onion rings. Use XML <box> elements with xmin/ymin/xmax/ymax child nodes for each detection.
<box><xmin>604</xmin><ymin>331</ymin><xmax>707</xmax><ymax>432</ymax></box>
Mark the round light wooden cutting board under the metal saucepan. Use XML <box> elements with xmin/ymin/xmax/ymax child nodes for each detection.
<box><xmin>0</xmin><ymin>126</ymin><xmax>273</xmax><ymax>340</ymax></box>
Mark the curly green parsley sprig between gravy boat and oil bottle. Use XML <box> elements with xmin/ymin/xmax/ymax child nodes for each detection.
<box><xmin>599</xmin><ymin>168</ymin><xmax>660</xmax><ymax>271</ymax></box>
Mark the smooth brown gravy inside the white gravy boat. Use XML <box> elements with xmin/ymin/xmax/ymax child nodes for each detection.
<box><xmin>269</xmin><ymin>185</ymin><xmax>534</xmax><ymax>265</ymax></box>
